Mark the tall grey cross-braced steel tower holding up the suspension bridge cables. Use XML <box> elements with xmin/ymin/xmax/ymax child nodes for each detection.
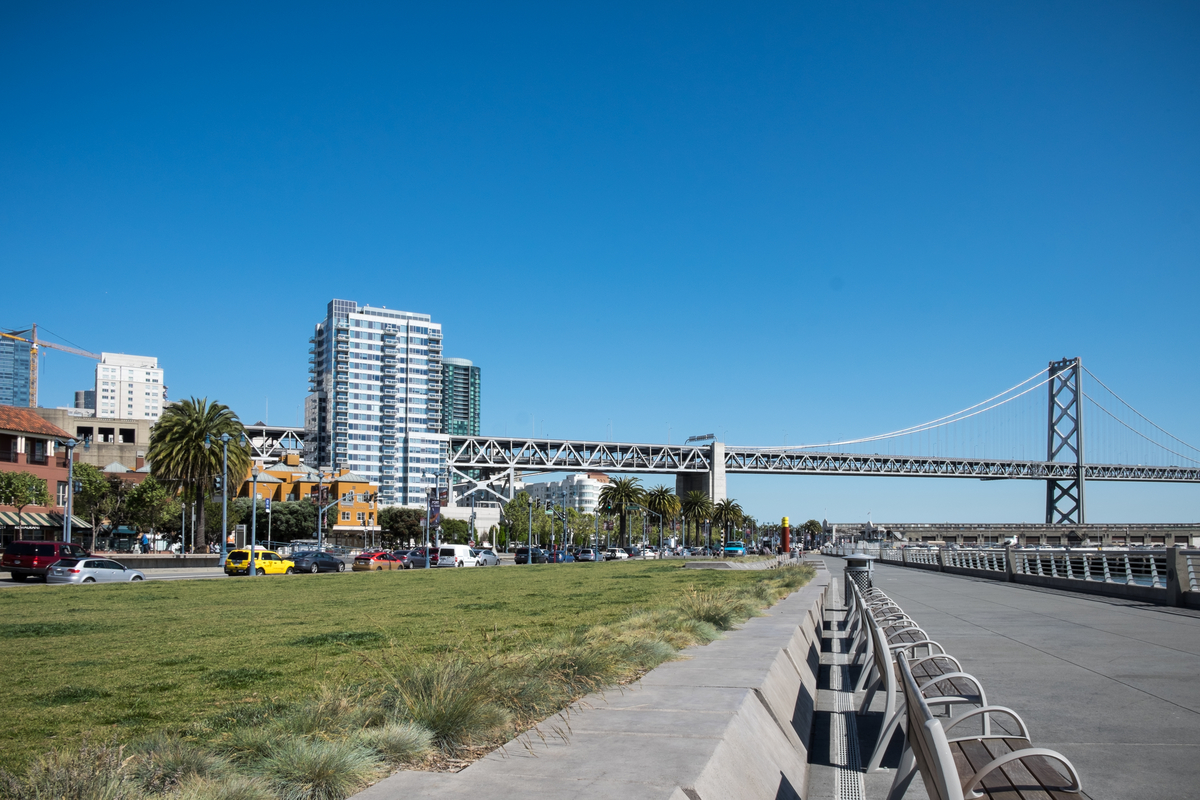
<box><xmin>1046</xmin><ymin>359</ymin><xmax>1086</xmax><ymax>525</ymax></box>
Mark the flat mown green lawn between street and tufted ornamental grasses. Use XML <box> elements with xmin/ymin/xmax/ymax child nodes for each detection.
<box><xmin>0</xmin><ymin>561</ymin><xmax>806</xmax><ymax>769</ymax></box>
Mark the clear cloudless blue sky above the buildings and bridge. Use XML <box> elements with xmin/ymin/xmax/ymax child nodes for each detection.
<box><xmin>0</xmin><ymin>0</ymin><xmax>1200</xmax><ymax>522</ymax></box>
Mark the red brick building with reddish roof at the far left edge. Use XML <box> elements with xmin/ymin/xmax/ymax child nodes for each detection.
<box><xmin>0</xmin><ymin>405</ymin><xmax>71</xmax><ymax>545</ymax></box>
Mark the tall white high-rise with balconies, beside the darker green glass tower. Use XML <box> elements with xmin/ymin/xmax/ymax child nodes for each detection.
<box><xmin>305</xmin><ymin>300</ymin><xmax>448</xmax><ymax>505</ymax></box>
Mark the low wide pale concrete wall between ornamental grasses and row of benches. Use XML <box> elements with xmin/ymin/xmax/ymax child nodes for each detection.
<box><xmin>356</xmin><ymin>561</ymin><xmax>830</xmax><ymax>800</ymax></box>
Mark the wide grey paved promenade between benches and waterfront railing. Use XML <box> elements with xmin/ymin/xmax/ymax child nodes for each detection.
<box><xmin>844</xmin><ymin>559</ymin><xmax>1200</xmax><ymax>800</ymax></box>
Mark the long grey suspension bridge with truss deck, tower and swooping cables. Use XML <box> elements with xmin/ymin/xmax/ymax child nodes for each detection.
<box><xmin>449</xmin><ymin>357</ymin><xmax>1200</xmax><ymax>524</ymax></box>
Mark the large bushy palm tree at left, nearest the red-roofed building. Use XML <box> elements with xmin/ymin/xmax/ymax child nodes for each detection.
<box><xmin>146</xmin><ymin>397</ymin><xmax>250</xmax><ymax>546</ymax></box>
